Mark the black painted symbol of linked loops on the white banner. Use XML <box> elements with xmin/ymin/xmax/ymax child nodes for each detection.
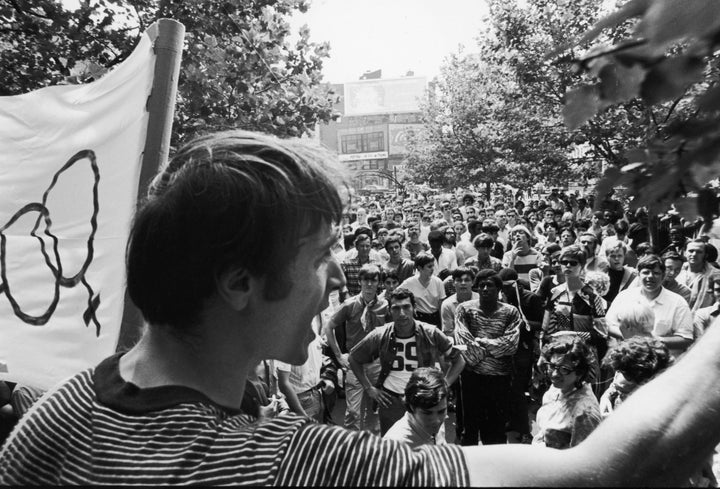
<box><xmin>0</xmin><ymin>149</ymin><xmax>100</xmax><ymax>336</ymax></box>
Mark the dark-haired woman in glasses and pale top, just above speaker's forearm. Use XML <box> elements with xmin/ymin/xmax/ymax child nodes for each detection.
<box><xmin>533</xmin><ymin>337</ymin><xmax>602</xmax><ymax>449</ymax></box>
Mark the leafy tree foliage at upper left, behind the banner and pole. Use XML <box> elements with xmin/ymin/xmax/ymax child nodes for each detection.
<box><xmin>0</xmin><ymin>0</ymin><xmax>335</xmax><ymax>145</ymax></box>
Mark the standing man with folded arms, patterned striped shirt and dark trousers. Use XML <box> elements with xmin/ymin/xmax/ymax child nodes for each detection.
<box><xmin>455</xmin><ymin>269</ymin><xmax>522</xmax><ymax>445</ymax></box>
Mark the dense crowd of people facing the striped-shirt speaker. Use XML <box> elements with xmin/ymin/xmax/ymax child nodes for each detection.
<box><xmin>0</xmin><ymin>184</ymin><xmax>720</xmax><ymax>485</ymax></box>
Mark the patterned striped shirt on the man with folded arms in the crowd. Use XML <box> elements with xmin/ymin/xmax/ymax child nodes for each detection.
<box><xmin>455</xmin><ymin>299</ymin><xmax>522</xmax><ymax>375</ymax></box>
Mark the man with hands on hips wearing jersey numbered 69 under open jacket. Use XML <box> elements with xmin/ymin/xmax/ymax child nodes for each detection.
<box><xmin>349</xmin><ymin>288</ymin><xmax>465</xmax><ymax>435</ymax></box>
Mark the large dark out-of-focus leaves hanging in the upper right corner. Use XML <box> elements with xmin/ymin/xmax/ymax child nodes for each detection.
<box><xmin>564</xmin><ymin>0</ymin><xmax>720</xmax><ymax>215</ymax></box>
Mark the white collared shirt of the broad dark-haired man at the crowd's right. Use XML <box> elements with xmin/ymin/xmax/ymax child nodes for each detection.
<box><xmin>605</xmin><ymin>287</ymin><xmax>693</xmax><ymax>355</ymax></box>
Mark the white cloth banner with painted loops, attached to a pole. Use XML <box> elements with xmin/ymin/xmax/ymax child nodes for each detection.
<box><xmin>0</xmin><ymin>28</ymin><xmax>157</xmax><ymax>388</ymax></box>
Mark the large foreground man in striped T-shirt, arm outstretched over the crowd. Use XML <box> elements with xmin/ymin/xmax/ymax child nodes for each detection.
<box><xmin>7</xmin><ymin>131</ymin><xmax>720</xmax><ymax>487</ymax></box>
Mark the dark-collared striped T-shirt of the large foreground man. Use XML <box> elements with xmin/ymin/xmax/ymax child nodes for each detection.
<box><xmin>0</xmin><ymin>354</ymin><xmax>469</xmax><ymax>486</ymax></box>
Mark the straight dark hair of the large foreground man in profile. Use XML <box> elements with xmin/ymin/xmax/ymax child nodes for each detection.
<box><xmin>126</xmin><ymin>131</ymin><xmax>348</xmax><ymax>329</ymax></box>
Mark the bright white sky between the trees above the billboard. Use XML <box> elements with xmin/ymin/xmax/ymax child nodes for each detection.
<box><xmin>291</xmin><ymin>0</ymin><xmax>488</xmax><ymax>83</ymax></box>
